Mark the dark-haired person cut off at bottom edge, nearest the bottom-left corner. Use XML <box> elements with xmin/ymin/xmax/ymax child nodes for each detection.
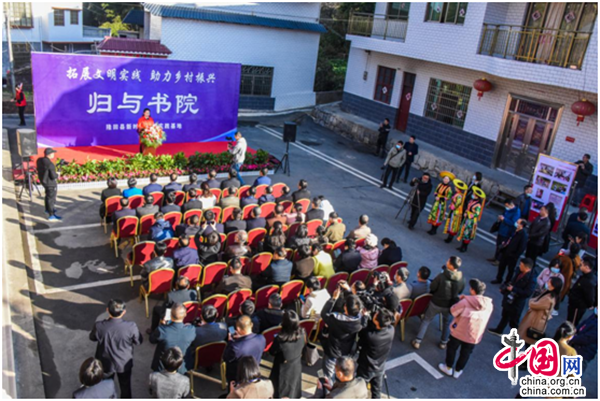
<box><xmin>73</xmin><ymin>358</ymin><xmax>119</xmax><ymax>398</ymax></box>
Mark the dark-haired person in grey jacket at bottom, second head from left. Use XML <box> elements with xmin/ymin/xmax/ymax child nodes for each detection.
<box><xmin>150</xmin><ymin>347</ymin><xmax>190</xmax><ymax>399</ymax></box>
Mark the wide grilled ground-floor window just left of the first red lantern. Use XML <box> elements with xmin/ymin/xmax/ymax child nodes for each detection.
<box><xmin>425</xmin><ymin>78</ymin><xmax>471</xmax><ymax>128</ymax></box>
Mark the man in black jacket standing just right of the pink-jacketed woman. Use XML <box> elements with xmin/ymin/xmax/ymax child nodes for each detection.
<box><xmin>488</xmin><ymin>258</ymin><xmax>536</xmax><ymax>336</ymax></box>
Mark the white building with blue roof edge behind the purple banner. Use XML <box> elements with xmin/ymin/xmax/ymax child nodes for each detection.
<box><xmin>144</xmin><ymin>3</ymin><xmax>325</xmax><ymax>111</ymax></box>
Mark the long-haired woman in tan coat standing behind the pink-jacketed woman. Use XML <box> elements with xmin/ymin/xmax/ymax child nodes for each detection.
<box><xmin>518</xmin><ymin>277</ymin><xmax>562</xmax><ymax>345</ymax></box>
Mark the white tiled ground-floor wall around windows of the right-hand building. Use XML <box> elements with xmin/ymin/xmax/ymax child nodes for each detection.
<box><xmin>344</xmin><ymin>48</ymin><xmax>598</xmax><ymax>171</ymax></box>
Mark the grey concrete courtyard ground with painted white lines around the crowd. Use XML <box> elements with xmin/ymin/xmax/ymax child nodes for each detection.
<box><xmin>3</xmin><ymin>115</ymin><xmax>598</xmax><ymax>398</ymax></box>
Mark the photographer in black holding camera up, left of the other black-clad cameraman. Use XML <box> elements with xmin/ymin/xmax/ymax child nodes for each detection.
<box><xmin>321</xmin><ymin>286</ymin><xmax>366</xmax><ymax>383</ymax></box>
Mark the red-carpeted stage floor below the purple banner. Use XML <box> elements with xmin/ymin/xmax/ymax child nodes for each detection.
<box><xmin>38</xmin><ymin>141</ymin><xmax>256</xmax><ymax>163</ymax></box>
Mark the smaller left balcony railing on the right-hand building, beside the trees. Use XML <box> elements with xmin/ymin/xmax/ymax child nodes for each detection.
<box><xmin>348</xmin><ymin>13</ymin><xmax>408</xmax><ymax>40</ymax></box>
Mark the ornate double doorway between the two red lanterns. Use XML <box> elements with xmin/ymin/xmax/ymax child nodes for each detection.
<box><xmin>497</xmin><ymin>96</ymin><xmax>562</xmax><ymax>179</ymax></box>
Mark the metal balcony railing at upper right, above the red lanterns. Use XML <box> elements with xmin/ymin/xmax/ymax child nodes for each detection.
<box><xmin>479</xmin><ymin>24</ymin><xmax>592</xmax><ymax>70</ymax></box>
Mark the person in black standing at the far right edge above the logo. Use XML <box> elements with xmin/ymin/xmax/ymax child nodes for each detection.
<box><xmin>567</xmin><ymin>256</ymin><xmax>598</xmax><ymax>326</ymax></box>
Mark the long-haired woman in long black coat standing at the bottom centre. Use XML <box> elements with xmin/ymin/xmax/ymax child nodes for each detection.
<box><xmin>269</xmin><ymin>310</ymin><xmax>306</xmax><ymax>398</ymax></box>
